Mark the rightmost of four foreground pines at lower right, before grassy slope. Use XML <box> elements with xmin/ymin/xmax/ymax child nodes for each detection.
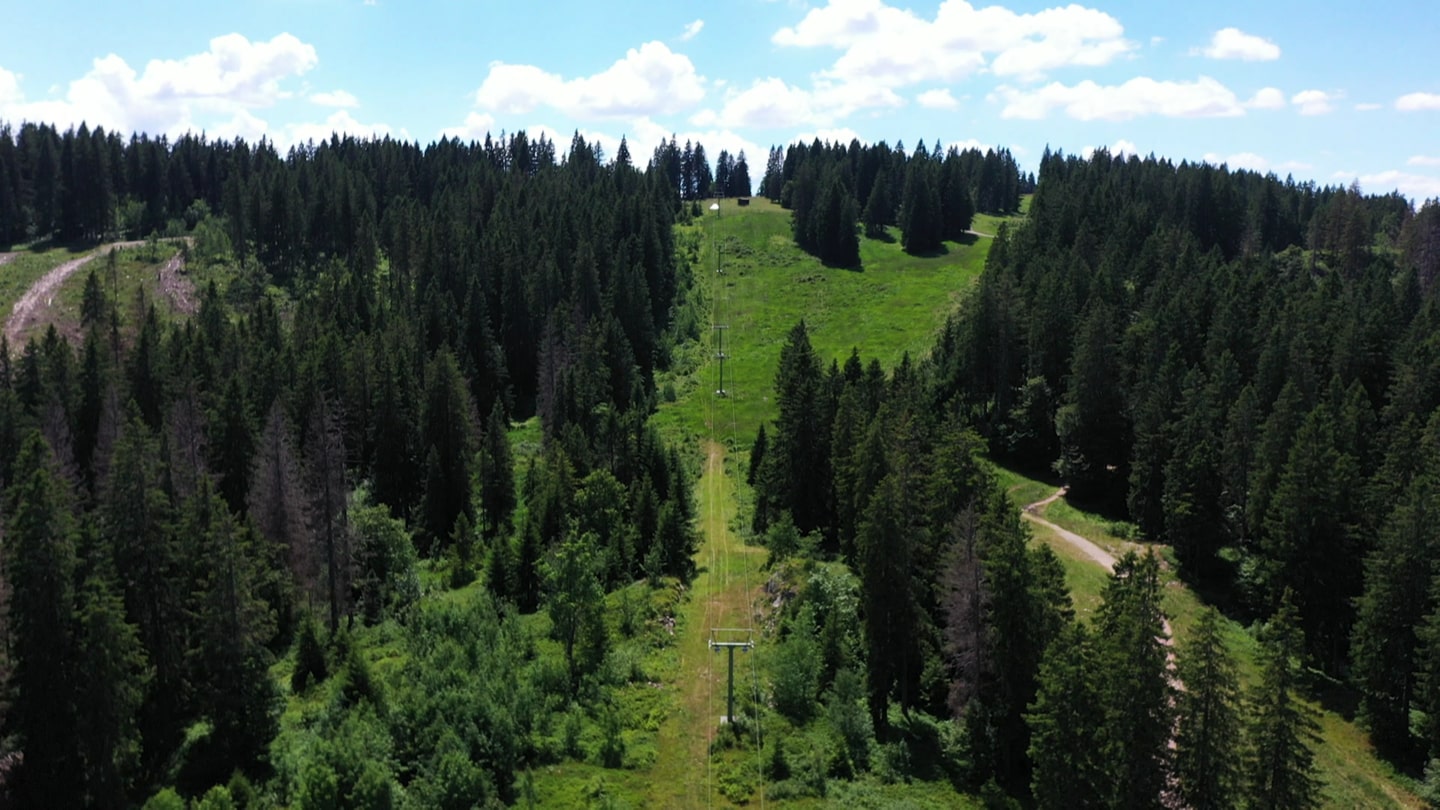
<box><xmin>1243</xmin><ymin>592</ymin><xmax>1320</xmax><ymax>810</ymax></box>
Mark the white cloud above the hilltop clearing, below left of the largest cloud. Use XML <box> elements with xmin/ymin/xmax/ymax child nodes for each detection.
<box><xmin>690</xmin><ymin>76</ymin><xmax>904</xmax><ymax>130</ymax></box>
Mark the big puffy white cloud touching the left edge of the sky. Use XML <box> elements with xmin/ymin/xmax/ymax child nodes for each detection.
<box><xmin>0</xmin><ymin>33</ymin><xmax>320</xmax><ymax>134</ymax></box>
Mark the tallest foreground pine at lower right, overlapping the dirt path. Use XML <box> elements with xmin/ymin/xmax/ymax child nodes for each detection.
<box><xmin>1097</xmin><ymin>552</ymin><xmax>1175</xmax><ymax>807</ymax></box>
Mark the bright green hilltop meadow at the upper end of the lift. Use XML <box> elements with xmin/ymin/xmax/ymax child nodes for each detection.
<box><xmin>655</xmin><ymin>199</ymin><xmax>991</xmax><ymax>448</ymax></box>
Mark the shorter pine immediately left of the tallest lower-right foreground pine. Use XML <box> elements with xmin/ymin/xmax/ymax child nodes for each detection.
<box><xmin>1025</xmin><ymin>623</ymin><xmax>1109</xmax><ymax>810</ymax></box>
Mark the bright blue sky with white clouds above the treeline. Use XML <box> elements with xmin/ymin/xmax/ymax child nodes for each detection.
<box><xmin>0</xmin><ymin>0</ymin><xmax>1440</xmax><ymax>200</ymax></box>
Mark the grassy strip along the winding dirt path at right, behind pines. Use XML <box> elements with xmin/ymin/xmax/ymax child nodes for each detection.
<box><xmin>999</xmin><ymin>470</ymin><xmax>1424</xmax><ymax>807</ymax></box>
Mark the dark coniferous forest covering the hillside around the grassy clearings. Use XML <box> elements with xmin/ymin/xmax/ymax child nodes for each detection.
<box><xmin>0</xmin><ymin>116</ymin><xmax>1440</xmax><ymax>809</ymax></box>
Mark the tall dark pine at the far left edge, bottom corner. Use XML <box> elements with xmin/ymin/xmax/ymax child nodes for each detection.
<box><xmin>4</xmin><ymin>431</ymin><xmax>84</xmax><ymax>807</ymax></box>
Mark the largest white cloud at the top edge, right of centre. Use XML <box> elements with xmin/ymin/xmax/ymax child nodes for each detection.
<box><xmin>770</xmin><ymin>0</ymin><xmax>1136</xmax><ymax>86</ymax></box>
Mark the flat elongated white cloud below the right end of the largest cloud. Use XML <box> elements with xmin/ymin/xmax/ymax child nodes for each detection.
<box><xmin>991</xmin><ymin>76</ymin><xmax>1244</xmax><ymax>121</ymax></box>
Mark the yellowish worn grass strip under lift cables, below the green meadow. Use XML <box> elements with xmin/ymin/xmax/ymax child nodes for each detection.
<box><xmin>647</xmin><ymin>440</ymin><xmax>768</xmax><ymax>807</ymax></box>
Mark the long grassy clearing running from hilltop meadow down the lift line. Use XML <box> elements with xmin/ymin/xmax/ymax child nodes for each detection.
<box><xmin>630</xmin><ymin>199</ymin><xmax>1013</xmax><ymax>807</ymax></box>
